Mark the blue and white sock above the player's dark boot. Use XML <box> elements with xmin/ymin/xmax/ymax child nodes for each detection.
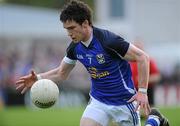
<box><xmin>145</xmin><ymin>115</ymin><xmax>160</xmax><ymax>126</ymax></box>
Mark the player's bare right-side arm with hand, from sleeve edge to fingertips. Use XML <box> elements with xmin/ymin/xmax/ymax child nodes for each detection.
<box><xmin>124</xmin><ymin>44</ymin><xmax>150</xmax><ymax>115</ymax></box>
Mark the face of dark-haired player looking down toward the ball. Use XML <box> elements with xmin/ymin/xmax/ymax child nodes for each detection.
<box><xmin>63</xmin><ymin>21</ymin><xmax>87</xmax><ymax>43</ymax></box>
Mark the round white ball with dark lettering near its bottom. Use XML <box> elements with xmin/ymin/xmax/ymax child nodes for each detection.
<box><xmin>30</xmin><ymin>79</ymin><xmax>59</xmax><ymax>108</ymax></box>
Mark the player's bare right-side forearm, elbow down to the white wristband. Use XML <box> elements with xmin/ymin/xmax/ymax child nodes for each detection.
<box><xmin>137</xmin><ymin>54</ymin><xmax>149</xmax><ymax>89</ymax></box>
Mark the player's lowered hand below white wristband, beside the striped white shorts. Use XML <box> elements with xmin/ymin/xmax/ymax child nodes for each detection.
<box><xmin>128</xmin><ymin>92</ymin><xmax>150</xmax><ymax>116</ymax></box>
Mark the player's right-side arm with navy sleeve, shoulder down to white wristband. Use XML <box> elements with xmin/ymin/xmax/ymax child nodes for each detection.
<box><xmin>103</xmin><ymin>31</ymin><xmax>149</xmax><ymax>90</ymax></box>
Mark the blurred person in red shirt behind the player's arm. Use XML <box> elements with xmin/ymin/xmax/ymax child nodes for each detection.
<box><xmin>130</xmin><ymin>39</ymin><xmax>161</xmax><ymax>106</ymax></box>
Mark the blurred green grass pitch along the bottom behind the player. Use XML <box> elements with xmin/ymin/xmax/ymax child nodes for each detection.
<box><xmin>0</xmin><ymin>107</ymin><xmax>180</xmax><ymax>126</ymax></box>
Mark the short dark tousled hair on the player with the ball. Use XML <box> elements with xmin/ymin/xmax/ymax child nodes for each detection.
<box><xmin>60</xmin><ymin>0</ymin><xmax>92</xmax><ymax>25</ymax></box>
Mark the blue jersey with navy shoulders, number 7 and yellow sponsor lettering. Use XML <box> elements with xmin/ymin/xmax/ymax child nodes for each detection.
<box><xmin>66</xmin><ymin>27</ymin><xmax>135</xmax><ymax>105</ymax></box>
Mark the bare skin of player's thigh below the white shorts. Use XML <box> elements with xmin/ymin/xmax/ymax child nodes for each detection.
<box><xmin>80</xmin><ymin>117</ymin><xmax>102</xmax><ymax>126</ymax></box>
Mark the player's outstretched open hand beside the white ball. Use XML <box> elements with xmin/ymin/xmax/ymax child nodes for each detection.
<box><xmin>16</xmin><ymin>70</ymin><xmax>37</xmax><ymax>94</ymax></box>
